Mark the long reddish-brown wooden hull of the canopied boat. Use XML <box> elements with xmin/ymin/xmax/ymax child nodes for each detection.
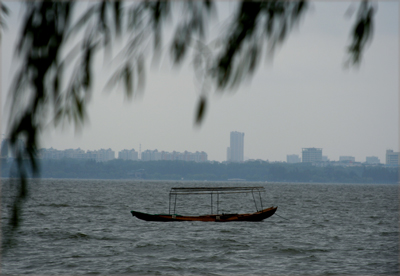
<box><xmin>131</xmin><ymin>207</ymin><xmax>278</xmax><ymax>222</ymax></box>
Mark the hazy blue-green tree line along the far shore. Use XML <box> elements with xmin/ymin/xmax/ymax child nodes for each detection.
<box><xmin>1</xmin><ymin>159</ymin><xmax>399</xmax><ymax>183</ymax></box>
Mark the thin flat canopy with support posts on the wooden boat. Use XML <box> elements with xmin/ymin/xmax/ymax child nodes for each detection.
<box><xmin>169</xmin><ymin>186</ymin><xmax>265</xmax><ymax>214</ymax></box>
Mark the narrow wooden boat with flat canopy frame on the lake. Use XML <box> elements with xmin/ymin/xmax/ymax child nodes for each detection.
<box><xmin>131</xmin><ymin>186</ymin><xmax>278</xmax><ymax>222</ymax></box>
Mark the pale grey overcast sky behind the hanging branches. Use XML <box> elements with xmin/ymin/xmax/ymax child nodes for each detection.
<box><xmin>1</xmin><ymin>1</ymin><xmax>399</xmax><ymax>163</ymax></box>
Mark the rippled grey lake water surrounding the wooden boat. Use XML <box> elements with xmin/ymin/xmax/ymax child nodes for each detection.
<box><xmin>1</xmin><ymin>180</ymin><xmax>400</xmax><ymax>275</ymax></box>
